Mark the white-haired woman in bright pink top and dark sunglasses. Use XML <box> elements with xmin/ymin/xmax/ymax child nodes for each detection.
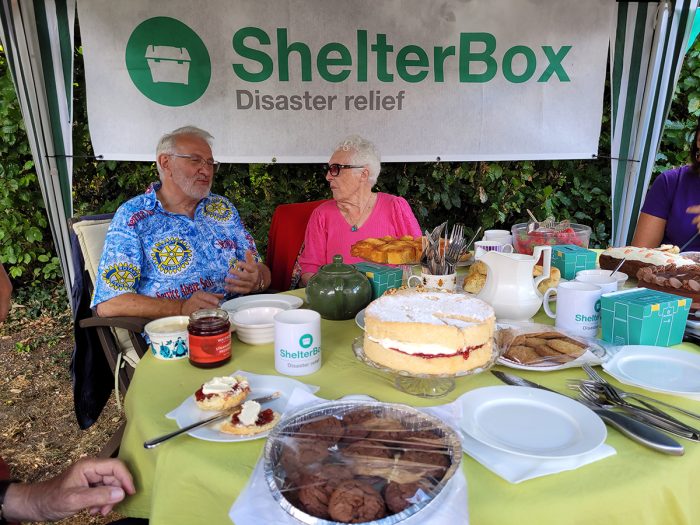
<box><xmin>299</xmin><ymin>135</ymin><xmax>421</xmax><ymax>285</ymax></box>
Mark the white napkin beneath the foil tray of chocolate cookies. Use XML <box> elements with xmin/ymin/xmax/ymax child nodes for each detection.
<box><xmin>228</xmin><ymin>389</ymin><xmax>469</xmax><ymax>525</ymax></box>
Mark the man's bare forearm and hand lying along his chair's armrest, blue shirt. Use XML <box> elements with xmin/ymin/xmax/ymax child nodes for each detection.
<box><xmin>96</xmin><ymin>290</ymin><xmax>224</xmax><ymax>319</ymax></box>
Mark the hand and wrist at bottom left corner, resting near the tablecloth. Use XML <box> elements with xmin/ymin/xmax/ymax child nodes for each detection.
<box><xmin>4</xmin><ymin>459</ymin><xmax>136</xmax><ymax>521</ymax></box>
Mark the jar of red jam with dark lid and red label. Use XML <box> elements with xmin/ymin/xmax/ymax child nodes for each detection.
<box><xmin>187</xmin><ymin>308</ymin><xmax>231</xmax><ymax>368</ymax></box>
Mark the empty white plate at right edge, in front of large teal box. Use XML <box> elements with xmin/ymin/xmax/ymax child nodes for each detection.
<box><xmin>603</xmin><ymin>345</ymin><xmax>700</xmax><ymax>396</ymax></box>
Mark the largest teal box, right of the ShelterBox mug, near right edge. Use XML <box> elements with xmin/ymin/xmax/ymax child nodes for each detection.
<box><xmin>600</xmin><ymin>288</ymin><xmax>691</xmax><ymax>346</ymax></box>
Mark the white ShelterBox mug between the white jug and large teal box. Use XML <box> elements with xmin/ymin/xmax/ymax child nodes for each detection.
<box><xmin>542</xmin><ymin>281</ymin><xmax>603</xmax><ymax>337</ymax></box>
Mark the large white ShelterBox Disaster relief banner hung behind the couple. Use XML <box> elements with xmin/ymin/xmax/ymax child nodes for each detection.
<box><xmin>78</xmin><ymin>0</ymin><xmax>615</xmax><ymax>162</ymax></box>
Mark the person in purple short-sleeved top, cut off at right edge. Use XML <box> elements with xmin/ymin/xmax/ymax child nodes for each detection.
<box><xmin>632</xmin><ymin>119</ymin><xmax>700</xmax><ymax>251</ymax></box>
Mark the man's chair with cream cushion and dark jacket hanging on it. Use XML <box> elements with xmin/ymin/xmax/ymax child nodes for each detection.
<box><xmin>69</xmin><ymin>214</ymin><xmax>149</xmax><ymax>456</ymax></box>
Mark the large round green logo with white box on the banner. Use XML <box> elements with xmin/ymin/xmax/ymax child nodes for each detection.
<box><xmin>125</xmin><ymin>16</ymin><xmax>211</xmax><ymax>106</ymax></box>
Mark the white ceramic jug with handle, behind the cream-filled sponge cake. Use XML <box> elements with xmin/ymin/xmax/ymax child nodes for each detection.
<box><xmin>477</xmin><ymin>246</ymin><xmax>552</xmax><ymax>321</ymax></box>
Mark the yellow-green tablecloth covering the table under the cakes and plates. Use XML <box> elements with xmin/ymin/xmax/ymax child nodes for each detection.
<box><xmin>118</xmin><ymin>291</ymin><xmax>700</xmax><ymax>525</ymax></box>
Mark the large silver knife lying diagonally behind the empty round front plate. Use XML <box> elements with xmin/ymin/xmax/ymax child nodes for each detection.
<box><xmin>491</xmin><ymin>370</ymin><xmax>685</xmax><ymax>456</ymax></box>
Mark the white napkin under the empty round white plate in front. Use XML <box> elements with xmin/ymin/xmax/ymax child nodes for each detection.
<box><xmin>446</xmin><ymin>392</ymin><xmax>617</xmax><ymax>483</ymax></box>
